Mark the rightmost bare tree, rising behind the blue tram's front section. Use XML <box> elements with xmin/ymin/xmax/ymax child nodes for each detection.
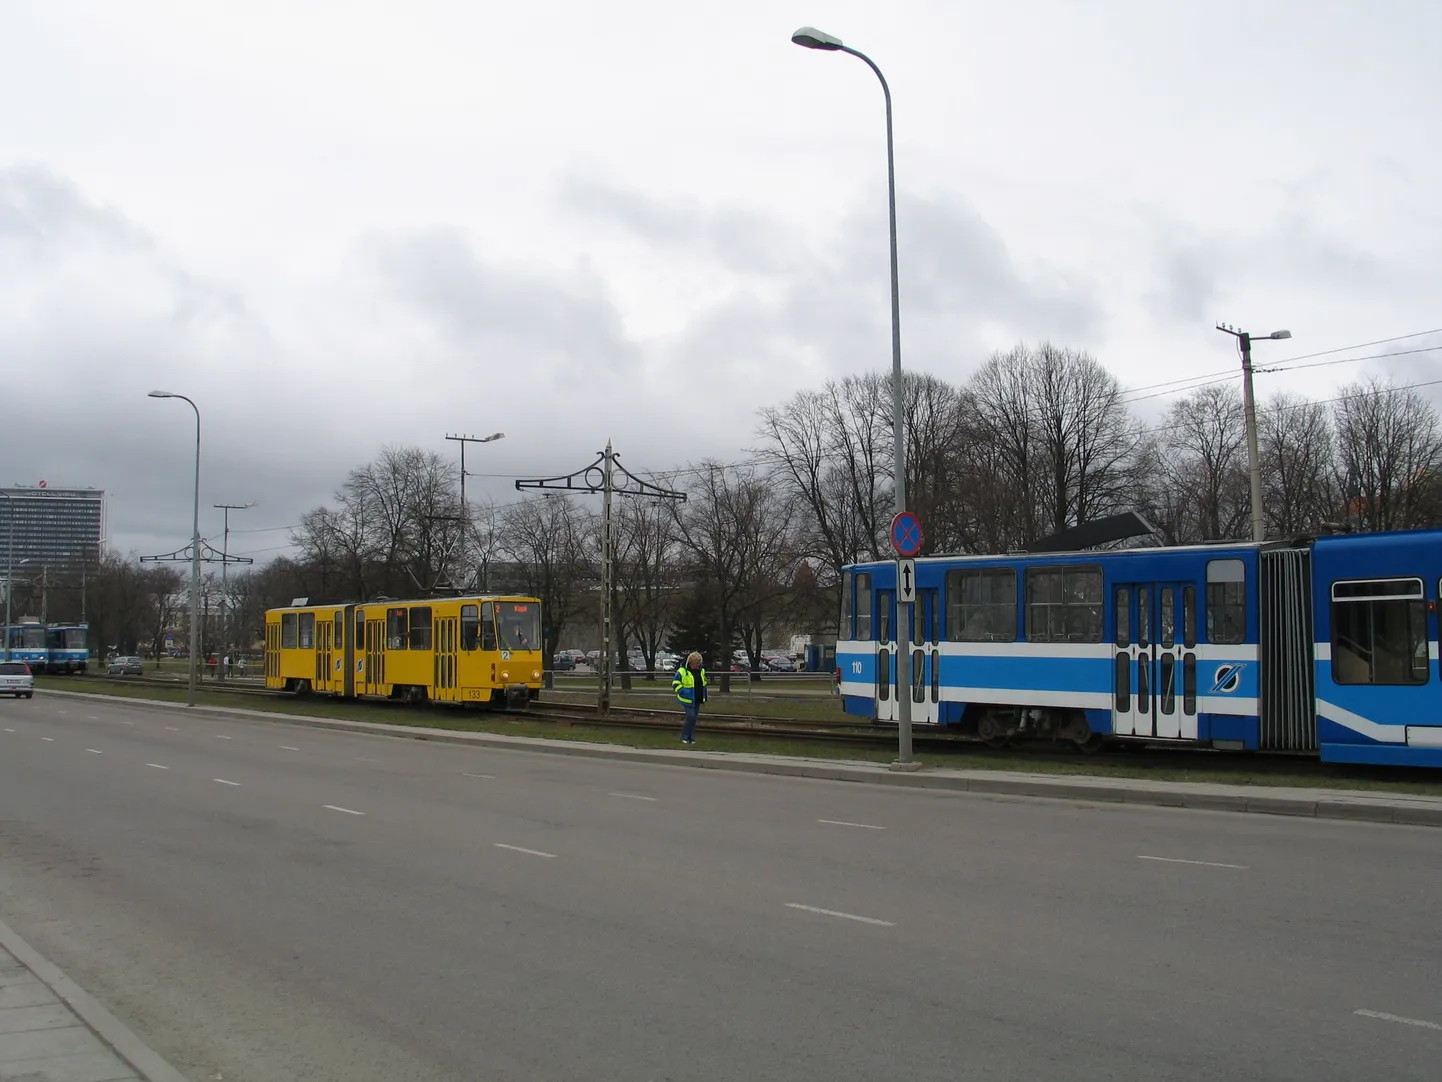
<box><xmin>1334</xmin><ymin>378</ymin><xmax>1442</xmax><ymax>529</ymax></box>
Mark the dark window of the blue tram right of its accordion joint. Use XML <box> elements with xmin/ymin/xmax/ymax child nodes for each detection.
<box><xmin>1332</xmin><ymin>579</ymin><xmax>1429</xmax><ymax>684</ymax></box>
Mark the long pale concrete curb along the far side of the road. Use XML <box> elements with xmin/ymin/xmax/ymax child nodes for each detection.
<box><xmin>48</xmin><ymin>690</ymin><xmax>1442</xmax><ymax>827</ymax></box>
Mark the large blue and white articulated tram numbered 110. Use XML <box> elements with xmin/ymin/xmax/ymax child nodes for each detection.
<box><xmin>836</xmin><ymin>531</ymin><xmax>1442</xmax><ymax>766</ymax></box>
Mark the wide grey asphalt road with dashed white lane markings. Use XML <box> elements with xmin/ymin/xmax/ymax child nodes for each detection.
<box><xmin>0</xmin><ymin>694</ymin><xmax>1442</xmax><ymax>1082</ymax></box>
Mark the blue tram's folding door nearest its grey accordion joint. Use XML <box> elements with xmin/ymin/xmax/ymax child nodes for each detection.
<box><xmin>1112</xmin><ymin>583</ymin><xmax>1197</xmax><ymax>740</ymax></box>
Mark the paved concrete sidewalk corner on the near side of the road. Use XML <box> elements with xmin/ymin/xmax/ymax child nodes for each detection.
<box><xmin>0</xmin><ymin>922</ymin><xmax>185</xmax><ymax>1082</ymax></box>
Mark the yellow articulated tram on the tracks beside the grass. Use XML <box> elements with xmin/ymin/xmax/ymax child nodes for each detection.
<box><xmin>265</xmin><ymin>596</ymin><xmax>545</xmax><ymax>707</ymax></box>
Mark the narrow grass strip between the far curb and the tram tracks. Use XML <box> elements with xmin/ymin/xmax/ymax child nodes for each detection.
<box><xmin>36</xmin><ymin>677</ymin><xmax>1442</xmax><ymax>796</ymax></box>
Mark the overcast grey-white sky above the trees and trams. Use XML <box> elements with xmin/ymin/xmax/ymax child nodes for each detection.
<box><xmin>0</xmin><ymin>0</ymin><xmax>1442</xmax><ymax>560</ymax></box>
